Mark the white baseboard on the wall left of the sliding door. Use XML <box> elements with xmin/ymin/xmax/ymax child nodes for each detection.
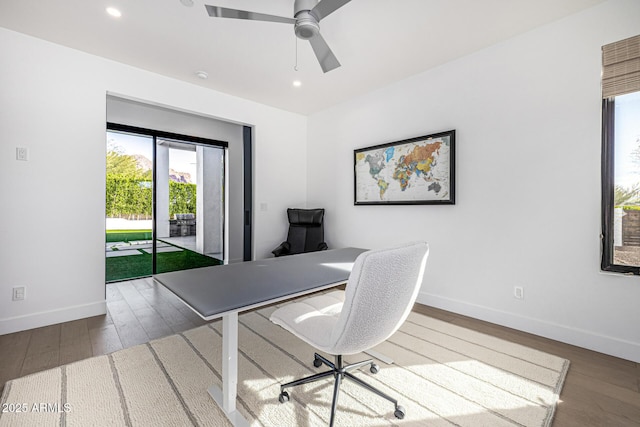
<box><xmin>0</xmin><ymin>301</ymin><xmax>107</xmax><ymax>335</ymax></box>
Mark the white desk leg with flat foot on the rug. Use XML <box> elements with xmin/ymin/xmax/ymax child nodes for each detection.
<box><xmin>209</xmin><ymin>312</ymin><xmax>249</xmax><ymax>427</ymax></box>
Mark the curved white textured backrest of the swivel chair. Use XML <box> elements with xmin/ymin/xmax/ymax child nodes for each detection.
<box><xmin>331</xmin><ymin>242</ymin><xmax>429</xmax><ymax>355</ymax></box>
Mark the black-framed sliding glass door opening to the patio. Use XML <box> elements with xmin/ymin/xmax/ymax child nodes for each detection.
<box><xmin>105</xmin><ymin>123</ymin><xmax>226</xmax><ymax>282</ymax></box>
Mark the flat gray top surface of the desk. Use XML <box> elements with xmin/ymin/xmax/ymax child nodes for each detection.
<box><xmin>154</xmin><ymin>248</ymin><xmax>366</xmax><ymax>319</ymax></box>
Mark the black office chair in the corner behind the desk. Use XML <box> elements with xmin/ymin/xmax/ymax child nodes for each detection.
<box><xmin>271</xmin><ymin>208</ymin><xmax>328</xmax><ymax>257</ymax></box>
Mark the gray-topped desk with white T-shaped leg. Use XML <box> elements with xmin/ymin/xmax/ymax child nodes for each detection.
<box><xmin>154</xmin><ymin>248</ymin><xmax>365</xmax><ymax>426</ymax></box>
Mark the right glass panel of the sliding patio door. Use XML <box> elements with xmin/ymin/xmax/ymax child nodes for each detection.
<box><xmin>154</xmin><ymin>138</ymin><xmax>224</xmax><ymax>273</ymax></box>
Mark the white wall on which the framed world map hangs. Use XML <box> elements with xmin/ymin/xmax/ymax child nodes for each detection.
<box><xmin>308</xmin><ymin>0</ymin><xmax>640</xmax><ymax>361</ymax></box>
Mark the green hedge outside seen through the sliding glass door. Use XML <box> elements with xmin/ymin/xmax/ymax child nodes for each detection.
<box><xmin>106</xmin><ymin>174</ymin><xmax>196</xmax><ymax>218</ymax></box>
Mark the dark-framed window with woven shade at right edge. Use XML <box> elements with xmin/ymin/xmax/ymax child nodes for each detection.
<box><xmin>602</xmin><ymin>36</ymin><xmax>640</xmax><ymax>274</ymax></box>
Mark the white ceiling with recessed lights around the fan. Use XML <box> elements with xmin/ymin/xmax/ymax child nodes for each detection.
<box><xmin>0</xmin><ymin>0</ymin><xmax>604</xmax><ymax>114</ymax></box>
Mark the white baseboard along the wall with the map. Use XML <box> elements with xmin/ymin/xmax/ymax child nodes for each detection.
<box><xmin>417</xmin><ymin>292</ymin><xmax>640</xmax><ymax>363</ymax></box>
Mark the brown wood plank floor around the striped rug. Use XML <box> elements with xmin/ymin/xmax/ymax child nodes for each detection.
<box><xmin>0</xmin><ymin>279</ymin><xmax>640</xmax><ymax>427</ymax></box>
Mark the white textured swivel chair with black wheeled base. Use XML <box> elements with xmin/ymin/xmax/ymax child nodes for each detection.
<box><xmin>270</xmin><ymin>242</ymin><xmax>429</xmax><ymax>426</ymax></box>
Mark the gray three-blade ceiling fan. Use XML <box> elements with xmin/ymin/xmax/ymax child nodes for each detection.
<box><xmin>205</xmin><ymin>0</ymin><xmax>351</xmax><ymax>73</ymax></box>
